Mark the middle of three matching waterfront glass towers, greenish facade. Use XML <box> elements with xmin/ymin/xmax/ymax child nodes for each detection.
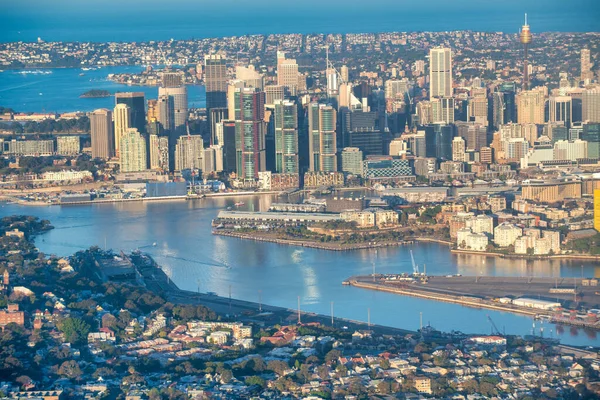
<box><xmin>275</xmin><ymin>100</ymin><xmax>299</xmax><ymax>174</ymax></box>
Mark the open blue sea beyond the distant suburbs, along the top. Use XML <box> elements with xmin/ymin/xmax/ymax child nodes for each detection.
<box><xmin>0</xmin><ymin>0</ymin><xmax>600</xmax><ymax>42</ymax></box>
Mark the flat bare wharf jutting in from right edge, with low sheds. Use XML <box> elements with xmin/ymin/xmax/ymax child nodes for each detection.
<box><xmin>344</xmin><ymin>275</ymin><xmax>600</xmax><ymax>329</ymax></box>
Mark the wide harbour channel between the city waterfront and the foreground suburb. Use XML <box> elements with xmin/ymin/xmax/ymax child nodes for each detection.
<box><xmin>0</xmin><ymin>200</ymin><xmax>600</xmax><ymax>345</ymax></box>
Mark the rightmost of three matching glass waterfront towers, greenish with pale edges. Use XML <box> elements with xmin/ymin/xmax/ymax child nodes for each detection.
<box><xmin>308</xmin><ymin>103</ymin><xmax>337</xmax><ymax>172</ymax></box>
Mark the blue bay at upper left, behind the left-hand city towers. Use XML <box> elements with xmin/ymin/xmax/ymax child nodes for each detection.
<box><xmin>0</xmin><ymin>66</ymin><xmax>206</xmax><ymax>113</ymax></box>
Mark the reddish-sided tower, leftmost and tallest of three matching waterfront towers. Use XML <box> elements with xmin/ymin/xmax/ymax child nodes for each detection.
<box><xmin>234</xmin><ymin>88</ymin><xmax>266</xmax><ymax>179</ymax></box>
